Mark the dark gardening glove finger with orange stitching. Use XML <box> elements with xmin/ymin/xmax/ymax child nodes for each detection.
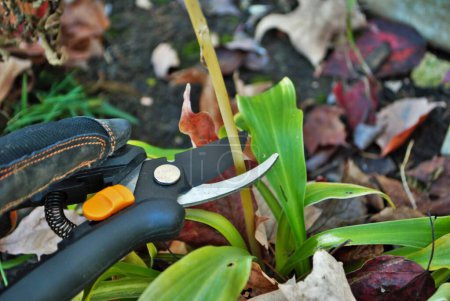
<box><xmin>0</xmin><ymin>117</ymin><xmax>131</xmax><ymax>237</ymax></box>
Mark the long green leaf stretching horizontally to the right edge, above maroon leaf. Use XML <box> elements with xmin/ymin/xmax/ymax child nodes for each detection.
<box><xmin>280</xmin><ymin>216</ymin><xmax>450</xmax><ymax>274</ymax></box>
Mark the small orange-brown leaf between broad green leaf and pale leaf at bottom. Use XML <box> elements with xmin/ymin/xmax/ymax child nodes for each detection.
<box><xmin>240</xmin><ymin>262</ymin><xmax>277</xmax><ymax>300</ymax></box>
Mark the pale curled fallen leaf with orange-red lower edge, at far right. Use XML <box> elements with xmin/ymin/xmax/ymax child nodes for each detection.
<box><xmin>377</xmin><ymin>98</ymin><xmax>445</xmax><ymax>156</ymax></box>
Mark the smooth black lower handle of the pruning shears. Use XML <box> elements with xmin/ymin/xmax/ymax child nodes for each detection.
<box><xmin>0</xmin><ymin>199</ymin><xmax>185</xmax><ymax>301</ymax></box>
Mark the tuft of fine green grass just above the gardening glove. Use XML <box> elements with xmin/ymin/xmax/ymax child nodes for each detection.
<box><xmin>5</xmin><ymin>75</ymin><xmax>138</xmax><ymax>132</ymax></box>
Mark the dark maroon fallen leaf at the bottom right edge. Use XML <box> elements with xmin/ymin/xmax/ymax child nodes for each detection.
<box><xmin>347</xmin><ymin>255</ymin><xmax>435</xmax><ymax>301</ymax></box>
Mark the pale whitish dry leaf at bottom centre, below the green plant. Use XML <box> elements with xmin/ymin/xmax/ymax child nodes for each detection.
<box><xmin>250</xmin><ymin>251</ymin><xmax>355</xmax><ymax>301</ymax></box>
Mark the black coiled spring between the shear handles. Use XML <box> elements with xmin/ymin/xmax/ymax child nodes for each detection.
<box><xmin>44</xmin><ymin>191</ymin><xmax>76</xmax><ymax>238</ymax></box>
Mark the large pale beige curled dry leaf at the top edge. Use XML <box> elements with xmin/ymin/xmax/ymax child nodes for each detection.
<box><xmin>255</xmin><ymin>0</ymin><xmax>366</xmax><ymax>66</ymax></box>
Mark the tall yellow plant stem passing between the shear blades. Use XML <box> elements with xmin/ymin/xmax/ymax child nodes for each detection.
<box><xmin>184</xmin><ymin>0</ymin><xmax>260</xmax><ymax>257</ymax></box>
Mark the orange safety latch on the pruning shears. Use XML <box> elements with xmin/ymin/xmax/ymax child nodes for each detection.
<box><xmin>83</xmin><ymin>185</ymin><xmax>134</xmax><ymax>221</ymax></box>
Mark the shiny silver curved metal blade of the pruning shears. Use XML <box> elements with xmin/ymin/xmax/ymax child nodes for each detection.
<box><xmin>177</xmin><ymin>154</ymin><xmax>278</xmax><ymax>207</ymax></box>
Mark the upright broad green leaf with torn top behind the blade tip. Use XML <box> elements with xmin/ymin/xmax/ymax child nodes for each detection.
<box><xmin>236</xmin><ymin>78</ymin><xmax>306</xmax><ymax>247</ymax></box>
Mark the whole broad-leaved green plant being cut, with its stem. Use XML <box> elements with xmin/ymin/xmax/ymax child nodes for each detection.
<box><xmin>72</xmin><ymin>1</ymin><xmax>450</xmax><ymax>300</ymax></box>
